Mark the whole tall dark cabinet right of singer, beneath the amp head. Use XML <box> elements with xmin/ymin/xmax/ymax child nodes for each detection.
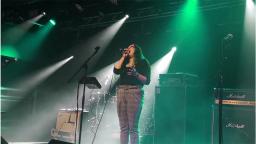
<box><xmin>154</xmin><ymin>85</ymin><xmax>206</xmax><ymax>144</ymax></box>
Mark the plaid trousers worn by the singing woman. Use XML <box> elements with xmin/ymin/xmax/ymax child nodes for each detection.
<box><xmin>117</xmin><ymin>85</ymin><xmax>143</xmax><ymax>144</ymax></box>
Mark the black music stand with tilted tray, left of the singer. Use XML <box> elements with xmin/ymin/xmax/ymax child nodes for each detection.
<box><xmin>75</xmin><ymin>76</ymin><xmax>101</xmax><ymax>144</ymax></box>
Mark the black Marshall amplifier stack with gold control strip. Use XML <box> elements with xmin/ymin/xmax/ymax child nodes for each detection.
<box><xmin>212</xmin><ymin>89</ymin><xmax>256</xmax><ymax>144</ymax></box>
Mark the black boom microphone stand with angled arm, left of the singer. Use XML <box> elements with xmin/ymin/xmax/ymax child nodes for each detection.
<box><xmin>68</xmin><ymin>46</ymin><xmax>100</xmax><ymax>144</ymax></box>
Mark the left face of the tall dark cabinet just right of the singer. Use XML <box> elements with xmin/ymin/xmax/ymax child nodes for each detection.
<box><xmin>154</xmin><ymin>87</ymin><xmax>186</xmax><ymax>144</ymax></box>
